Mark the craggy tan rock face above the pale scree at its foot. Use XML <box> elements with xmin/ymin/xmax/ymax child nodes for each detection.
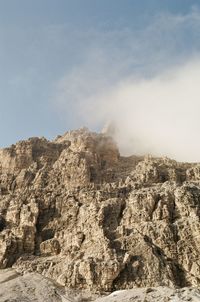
<box><xmin>0</xmin><ymin>129</ymin><xmax>200</xmax><ymax>292</ymax></box>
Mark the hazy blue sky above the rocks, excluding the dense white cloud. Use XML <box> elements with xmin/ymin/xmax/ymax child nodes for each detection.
<box><xmin>0</xmin><ymin>0</ymin><xmax>200</xmax><ymax>147</ymax></box>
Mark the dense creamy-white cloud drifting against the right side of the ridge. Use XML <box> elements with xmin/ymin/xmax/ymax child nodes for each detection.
<box><xmin>85</xmin><ymin>60</ymin><xmax>200</xmax><ymax>161</ymax></box>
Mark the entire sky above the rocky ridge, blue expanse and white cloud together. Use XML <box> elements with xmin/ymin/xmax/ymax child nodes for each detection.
<box><xmin>0</xmin><ymin>0</ymin><xmax>200</xmax><ymax>161</ymax></box>
